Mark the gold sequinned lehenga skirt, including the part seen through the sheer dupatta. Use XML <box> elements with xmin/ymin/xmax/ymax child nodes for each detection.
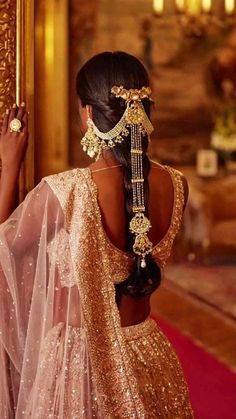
<box><xmin>27</xmin><ymin>319</ymin><xmax>193</xmax><ymax>419</ymax></box>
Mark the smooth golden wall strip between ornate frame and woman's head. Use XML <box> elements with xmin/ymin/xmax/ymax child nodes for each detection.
<box><xmin>35</xmin><ymin>0</ymin><xmax>68</xmax><ymax>181</ymax></box>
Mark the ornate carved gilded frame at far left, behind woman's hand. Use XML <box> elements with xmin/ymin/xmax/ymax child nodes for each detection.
<box><xmin>0</xmin><ymin>0</ymin><xmax>34</xmax><ymax>199</ymax></box>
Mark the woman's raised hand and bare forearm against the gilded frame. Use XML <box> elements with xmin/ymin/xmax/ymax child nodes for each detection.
<box><xmin>0</xmin><ymin>103</ymin><xmax>28</xmax><ymax>223</ymax></box>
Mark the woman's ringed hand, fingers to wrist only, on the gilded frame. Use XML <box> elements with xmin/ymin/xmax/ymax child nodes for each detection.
<box><xmin>0</xmin><ymin>103</ymin><xmax>28</xmax><ymax>174</ymax></box>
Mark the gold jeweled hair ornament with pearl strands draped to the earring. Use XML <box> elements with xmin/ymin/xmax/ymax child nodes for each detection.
<box><xmin>81</xmin><ymin>86</ymin><xmax>153</xmax><ymax>268</ymax></box>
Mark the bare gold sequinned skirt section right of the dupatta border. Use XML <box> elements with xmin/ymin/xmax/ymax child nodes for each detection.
<box><xmin>123</xmin><ymin>319</ymin><xmax>193</xmax><ymax>419</ymax></box>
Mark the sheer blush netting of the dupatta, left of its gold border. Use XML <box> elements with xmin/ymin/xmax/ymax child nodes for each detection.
<box><xmin>0</xmin><ymin>181</ymin><xmax>97</xmax><ymax>419</ymax></box>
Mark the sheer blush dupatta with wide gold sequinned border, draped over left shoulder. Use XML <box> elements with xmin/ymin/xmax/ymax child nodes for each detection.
<box><xmin>0</xmin><ymin>169</ymin><xmax>145</xmax><ymax>419</ymax></box>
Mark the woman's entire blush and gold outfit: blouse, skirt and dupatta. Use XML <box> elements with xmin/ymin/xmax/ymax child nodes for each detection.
<box><xmin>0</xmin><ymin>169</ymin><xmax>192</xmax><ymax>419</ymax></box>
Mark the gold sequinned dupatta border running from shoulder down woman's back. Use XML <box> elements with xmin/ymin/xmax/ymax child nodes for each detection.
<box><xmin>45</xmin><ymin>169</ymin><xmax>146</xmax><ymax>419</ymax></box>
